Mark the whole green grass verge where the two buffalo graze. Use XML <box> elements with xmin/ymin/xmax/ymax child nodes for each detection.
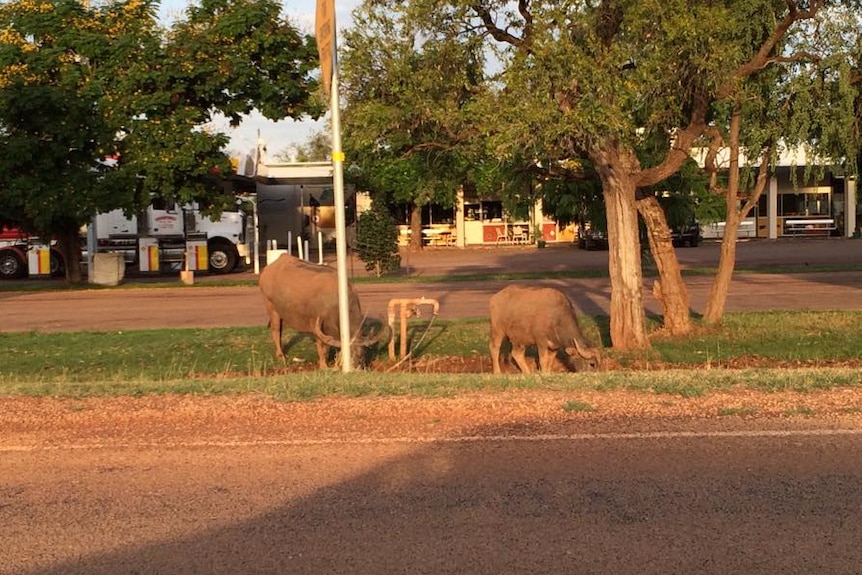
<box><xmin>0</xmin><ymin>311</ymin><xmax>862</xmax><ymax>400</ymax></box>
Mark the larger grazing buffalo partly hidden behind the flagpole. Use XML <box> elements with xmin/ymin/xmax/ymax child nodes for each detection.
<box><xmin>258</xmin><ymin>254</ymin><xmax>391</xmax><ymax>368</ymax></box>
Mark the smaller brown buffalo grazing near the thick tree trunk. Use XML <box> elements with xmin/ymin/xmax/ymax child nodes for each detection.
<box><xmin>489</xmin><ymin>285</ymin><xmax>602</xmax><ymax>373</ymax></box>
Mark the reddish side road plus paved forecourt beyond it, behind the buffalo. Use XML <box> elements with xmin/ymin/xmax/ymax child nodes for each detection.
<box><xmin>5</xmin><ymin>240</ymin><xmax>862</xmax><ymax>331</ymax></box>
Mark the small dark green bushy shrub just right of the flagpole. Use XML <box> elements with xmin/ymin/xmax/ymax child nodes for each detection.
<box><xmin>356</xmin><ymin>201</ymin><xmax>401</xmax><ymax>277</ymax></box>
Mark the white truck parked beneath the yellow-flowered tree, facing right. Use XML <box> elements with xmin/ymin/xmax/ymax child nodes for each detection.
<box><xmin>93</xmin><ymin>202</ymin><xmax>254</xmax><ymax>274</ymax></box>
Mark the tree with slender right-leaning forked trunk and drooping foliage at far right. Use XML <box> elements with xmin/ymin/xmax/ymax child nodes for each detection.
<box><xmin>704</xmin><ymin>3</ymin><xmax>862</xmax><ymax>323</ymax></box>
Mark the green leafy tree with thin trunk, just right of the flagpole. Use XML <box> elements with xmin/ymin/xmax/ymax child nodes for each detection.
<box><xmin>341</xmin><ymin>0</ymin><xmax>483</xmax><ymax>249</ymax></box>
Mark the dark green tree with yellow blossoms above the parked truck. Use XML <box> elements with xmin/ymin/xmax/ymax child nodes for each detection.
<box><xmin>0</xmin><ymin>0</ymin><xmax>322</xmax><ymax>281</ymax></box>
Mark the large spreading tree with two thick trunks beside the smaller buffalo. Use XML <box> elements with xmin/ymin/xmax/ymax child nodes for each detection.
<box><xmin>414</xmin><ymin>0</ymin><xmax>860</xmax><ymax>349</ymax></box>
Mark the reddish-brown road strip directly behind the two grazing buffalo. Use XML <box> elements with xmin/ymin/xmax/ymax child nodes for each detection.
<box><xmin>5</xmin><ymin>272</ymin><xmax>862</xmax><ymax>332</ymax></box>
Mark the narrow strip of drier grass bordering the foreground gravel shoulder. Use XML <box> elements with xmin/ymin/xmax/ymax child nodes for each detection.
<box><xmin>0</xmin><ymin>368</ymin><xmax>862</xmax><ymax>402</ymax></box>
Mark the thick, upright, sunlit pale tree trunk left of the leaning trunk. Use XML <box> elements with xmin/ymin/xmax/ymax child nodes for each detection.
<box><xmin>591</xmin><ymin>147</ymin><xmax>650</xmax><ymax>351</ymax></box>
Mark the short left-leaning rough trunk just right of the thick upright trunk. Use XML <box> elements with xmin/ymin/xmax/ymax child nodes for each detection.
<box><xmin>637</xmin><ymin>196</ymin><xmax>692</xmax><ymax>336</ymax></box>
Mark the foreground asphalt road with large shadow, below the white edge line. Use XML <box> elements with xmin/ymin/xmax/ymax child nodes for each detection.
<box><xmin>5</xmin><ymin>429</ymin><xmax>862</xmax><ymax>575</ymax></box>
